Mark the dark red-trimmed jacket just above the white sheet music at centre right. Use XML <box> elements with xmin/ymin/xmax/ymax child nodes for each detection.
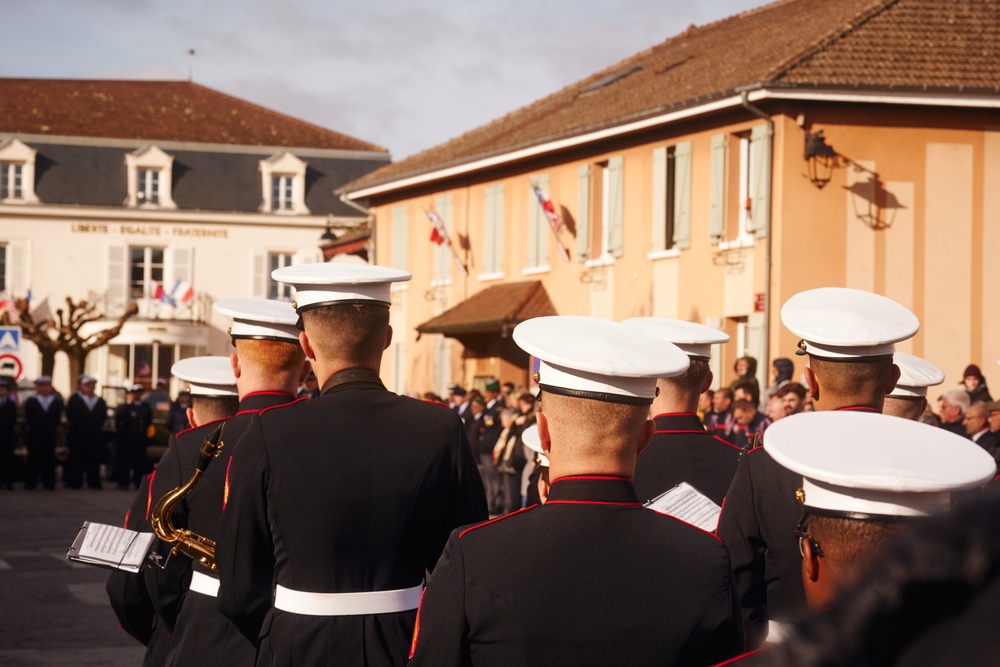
<box><xmin>635</xmin><ymin>412</ymin><xmax>740</xmax><ymax>505</ymax></box>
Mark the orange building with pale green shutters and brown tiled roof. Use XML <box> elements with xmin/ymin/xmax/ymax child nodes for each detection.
<box><xmin>344</xmin><ymin>0</ymin><xmax>1000</xmax><ymax>392</ymax></box>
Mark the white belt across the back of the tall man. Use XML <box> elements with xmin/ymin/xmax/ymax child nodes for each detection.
<box><xmin>274</xmin><ymin>584</ymin><xmax>424</xmax><ymax>616</ymax></box>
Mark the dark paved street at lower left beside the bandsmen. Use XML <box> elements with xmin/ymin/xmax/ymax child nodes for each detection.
<box><xmin>0</xmin><ymin>484</ymin><xmax>145</xmax><ymax>667</ymax></box>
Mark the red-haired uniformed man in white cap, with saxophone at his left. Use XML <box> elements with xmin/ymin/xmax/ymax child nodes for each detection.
<box><xmin>153</xmin><ymin>299</ymin><xmax>310</xmax><ymax>666</ymax></box>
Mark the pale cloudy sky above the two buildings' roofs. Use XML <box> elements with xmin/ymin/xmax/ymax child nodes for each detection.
<box><xmin>0</xmin><ymin>0</ymin><xmax>766</xmax><ymax>159</ymax></box>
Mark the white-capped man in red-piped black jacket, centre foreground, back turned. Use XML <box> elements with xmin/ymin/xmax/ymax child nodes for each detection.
<box><xmin>411</xmin><ymin>317</ymin><xmax>743</xmax><ymax>667</ymax></box>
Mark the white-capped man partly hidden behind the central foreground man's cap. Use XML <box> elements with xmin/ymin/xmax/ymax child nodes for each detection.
<box><xmin>622</xmin><ymin>317</ymin><xmax>740</xmax><ymax>505</ymax></box>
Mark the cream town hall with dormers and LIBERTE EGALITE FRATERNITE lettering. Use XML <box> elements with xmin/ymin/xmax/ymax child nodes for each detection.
<box><xmin>0</xmin><ymin>79</ymin><xmax>389</xmax><ymax>402</ymax></box>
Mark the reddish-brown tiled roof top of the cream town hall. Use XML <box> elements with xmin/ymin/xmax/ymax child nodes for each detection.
<box><xmin>0</xmin><ymin>78</ymin><xmax>385</xmax><ymax>151</ymax></box>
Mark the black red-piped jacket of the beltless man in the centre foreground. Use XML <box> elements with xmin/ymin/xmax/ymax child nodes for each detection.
<box><xmin>410</xmin><ymin>476</ymin><xmax>743</xmax><ymax>667</ymax></box>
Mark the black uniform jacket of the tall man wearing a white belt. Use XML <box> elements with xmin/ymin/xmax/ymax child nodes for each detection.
<box><xmin>217</xmin><ymin>369</ymin><xmax>487</xmax><ymax>666</ymax></box>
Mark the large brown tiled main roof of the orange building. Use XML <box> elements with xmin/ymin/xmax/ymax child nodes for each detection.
<box><xmin>344</xmin><ymin>0</ymin><xmax>1000</xmax><ymax>191</ymax></box>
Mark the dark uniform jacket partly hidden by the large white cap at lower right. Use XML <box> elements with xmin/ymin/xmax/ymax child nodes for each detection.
<box><xmin>717</xmin><ymin>408</ymin><xmax>874</xmax><ymax>647</ymax></box>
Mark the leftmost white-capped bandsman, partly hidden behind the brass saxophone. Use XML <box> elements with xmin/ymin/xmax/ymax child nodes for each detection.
<box><xmin>107</xmin><ymin>357</ymin><xmax>241</xmax><ymax>667</ymax></box>
